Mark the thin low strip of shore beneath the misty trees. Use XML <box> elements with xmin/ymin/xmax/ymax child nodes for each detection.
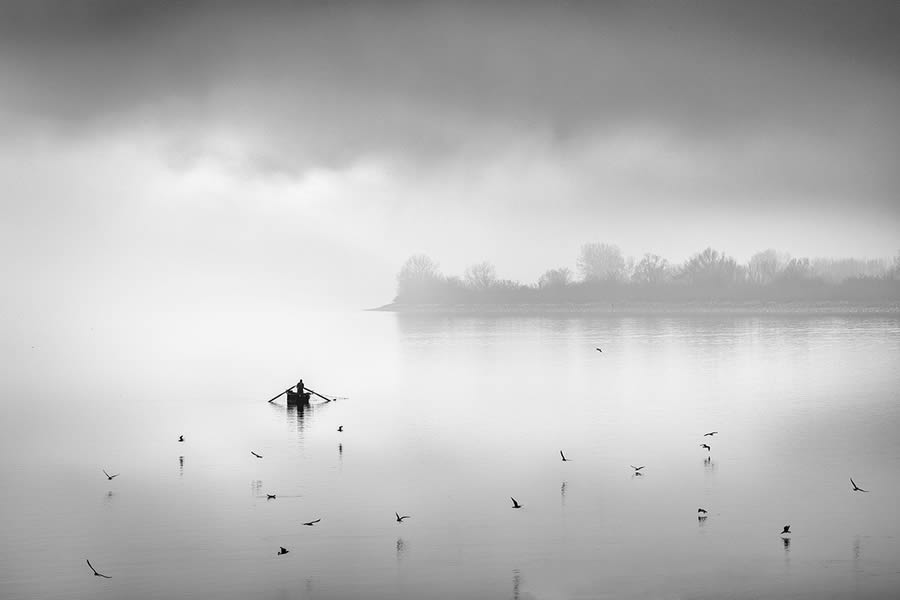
<box><xmin>366</xmin><ymin>301</ymin><xmax>900</xmax><ymax>317</ymax></box>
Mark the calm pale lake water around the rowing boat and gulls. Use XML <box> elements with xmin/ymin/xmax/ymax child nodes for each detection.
<box><xmin>0</xmin><ymin>313</ymin><xmax>900</xmax><ymax>599</ymax></box>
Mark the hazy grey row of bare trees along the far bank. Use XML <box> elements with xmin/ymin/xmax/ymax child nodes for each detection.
<box><xmin>394</xmin><ymin>243</ymin><xmax>900</xmax><ymax>304</ymax></box>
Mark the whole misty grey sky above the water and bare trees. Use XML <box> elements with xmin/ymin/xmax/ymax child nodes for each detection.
<box><xmin>0</xmin><ymin>0</ymin><xmax>900</xmax><ymax>314</ymax></box>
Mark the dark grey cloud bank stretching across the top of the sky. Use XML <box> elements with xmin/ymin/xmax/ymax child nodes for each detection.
<box><xmin>0</xmin><ymin>1</ymin><xmax>900</xmax><ymax>178</ymax></box>
